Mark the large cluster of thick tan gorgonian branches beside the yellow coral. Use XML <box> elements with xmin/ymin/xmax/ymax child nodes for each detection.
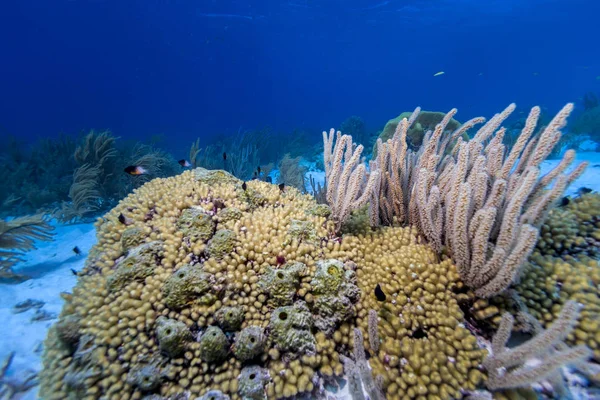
<box><xmin>371</xmin><ymin>104</ymin><xmax>586</xmax><ymax>297</ymax></box>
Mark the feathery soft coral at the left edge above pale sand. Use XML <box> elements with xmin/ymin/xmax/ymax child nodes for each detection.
<box><xmin>0</xmin><ymin>214</ymin><xmax>54</xmax><ymax>283</ymax></box>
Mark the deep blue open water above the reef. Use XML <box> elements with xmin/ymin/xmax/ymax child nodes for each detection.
<box><xmin>0</xmin><ymin>0</ymin><xmax>600</xmax><ymax>150</ymax></box>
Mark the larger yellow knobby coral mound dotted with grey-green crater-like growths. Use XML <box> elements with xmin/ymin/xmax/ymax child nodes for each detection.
<box><xmin>40</xmin><ymin>169</ymin><xmax>359</xmax><ymax>399</ymax></box>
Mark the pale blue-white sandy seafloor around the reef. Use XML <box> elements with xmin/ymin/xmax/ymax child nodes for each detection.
<box><xmin>0</xmin><ymin>152</ymin><xmax>600</xmax><ymax>400</ymax></box>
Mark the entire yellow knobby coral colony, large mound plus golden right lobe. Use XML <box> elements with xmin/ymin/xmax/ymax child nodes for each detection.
<box><xmin>40</xmin><ymin>168</ymin><xmax>483</xmax><ymax>400</ymax></box>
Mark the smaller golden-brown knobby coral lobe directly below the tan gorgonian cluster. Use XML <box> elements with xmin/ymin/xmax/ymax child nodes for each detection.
<box><xmin>342</xmin><ymin>228</ymin><xmax>486</xmax><ymax>399</ymax></box>
